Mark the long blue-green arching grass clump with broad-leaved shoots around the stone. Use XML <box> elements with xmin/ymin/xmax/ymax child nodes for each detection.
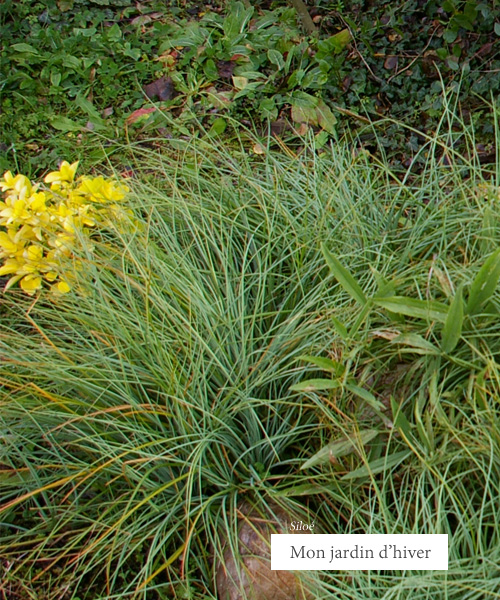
<box><xmin>0</xmin><ymin>102</ymin><xmax>500</xmax><ymax>600</ymax></box>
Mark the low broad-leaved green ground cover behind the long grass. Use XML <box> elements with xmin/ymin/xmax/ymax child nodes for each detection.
<box><xmin>0</xmin><ymin>0</ymin><xmax>500</xmax><ymax>177</ymax></box>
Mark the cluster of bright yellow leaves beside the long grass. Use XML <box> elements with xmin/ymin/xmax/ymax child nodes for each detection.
<box><xmin>0</xmin><ymin>161</ymin><xmax>129</xmax><ymax>294</ymax></box>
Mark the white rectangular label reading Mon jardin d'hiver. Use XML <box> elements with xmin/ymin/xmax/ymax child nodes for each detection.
<box><xmin>271</xmin><ymin>534</ymin><xmax>448</xmax><ymax>571</ymax></box>
